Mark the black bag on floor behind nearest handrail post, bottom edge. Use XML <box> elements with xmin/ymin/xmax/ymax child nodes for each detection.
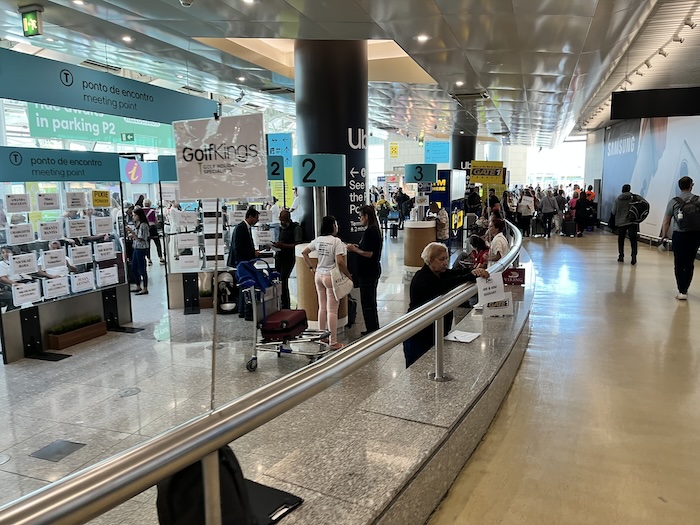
<box><xmin>156</xmin><ymin>447</ymin><xmax>258</xmax><ymax>525</ymax></box>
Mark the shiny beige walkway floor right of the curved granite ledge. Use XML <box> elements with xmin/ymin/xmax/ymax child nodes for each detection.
<box><xmin>429</xmin><ymin>234</ymin><xmax>700</xmax><ymax>525</ymax></box>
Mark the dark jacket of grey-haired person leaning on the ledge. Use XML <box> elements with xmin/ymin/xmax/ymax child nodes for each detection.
<box><xmin>404</xmin><ymin>264</ymin><xmax>476</xmax><ymax>366</ymax></box>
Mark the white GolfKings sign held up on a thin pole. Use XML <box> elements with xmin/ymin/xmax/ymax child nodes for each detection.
<box><xmin>173</xmin><ymin>114</ymin><xmax>267</xmax><ymax>199</ymax></box>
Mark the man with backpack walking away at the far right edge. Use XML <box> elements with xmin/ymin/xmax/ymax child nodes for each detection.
<box><xmin>661</xmin><ymin>177</ymin><xmax>700</xmax><ymax>301</ymax></box>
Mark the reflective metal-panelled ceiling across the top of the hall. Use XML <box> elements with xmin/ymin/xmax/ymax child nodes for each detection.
<box><xmin>0</xmin><ymin>0</ymin><xmax>700</xmax><ymax>146</ymax></box>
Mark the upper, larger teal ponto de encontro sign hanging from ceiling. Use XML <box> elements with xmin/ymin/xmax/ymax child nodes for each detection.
<box><xmin>0</xmin><ymin>49</ymin><xmax>218</xmax><ymax>124</ymax></box>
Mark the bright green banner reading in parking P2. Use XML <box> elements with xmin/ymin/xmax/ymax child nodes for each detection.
<box><xmin>27</xmin><ymin>104</ymin><xmax>175</xmax><ymax>148</ymax></box>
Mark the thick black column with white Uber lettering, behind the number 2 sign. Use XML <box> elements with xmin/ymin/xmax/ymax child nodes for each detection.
<box><xmin>294</xmin><ymin>40</ymin><xmax>367</xmax><ymax>242</ymax></box>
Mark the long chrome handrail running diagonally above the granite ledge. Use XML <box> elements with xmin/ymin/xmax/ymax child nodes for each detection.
<box><xmin>0</xmin><ymin>223</ymin><xmax>522</xmax><ymax>525</ymax></box>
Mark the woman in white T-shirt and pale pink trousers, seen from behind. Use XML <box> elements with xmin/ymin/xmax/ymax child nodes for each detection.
<box><xmin>302</xmin><ymin>215</ymin><xmax>352</xmax><ymax>350</ymax></box>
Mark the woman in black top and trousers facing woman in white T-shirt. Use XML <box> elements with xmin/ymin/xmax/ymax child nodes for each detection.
<box><xmin>347</xmin><ymin>206</ymin><xmax>382</xmax><ymax>335</ymax></box>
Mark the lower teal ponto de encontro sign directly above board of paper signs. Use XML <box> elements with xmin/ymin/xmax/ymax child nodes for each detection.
<box><xmin>0</xmin><ymin>147</ymin><xmax>119</xmax><ymax>182</ymax></box>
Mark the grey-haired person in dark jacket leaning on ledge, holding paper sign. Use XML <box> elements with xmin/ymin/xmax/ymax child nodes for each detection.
<box><xmin>403</xmin><ymin>242</ymin><xmax>489</xmax><ymax>368</ymax></box>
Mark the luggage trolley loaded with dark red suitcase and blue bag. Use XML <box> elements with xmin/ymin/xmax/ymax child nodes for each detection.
<box><xmin>236</xmin><ymin>259</ymin><xmax>331</xmax><ymax>372</ymax></box>
